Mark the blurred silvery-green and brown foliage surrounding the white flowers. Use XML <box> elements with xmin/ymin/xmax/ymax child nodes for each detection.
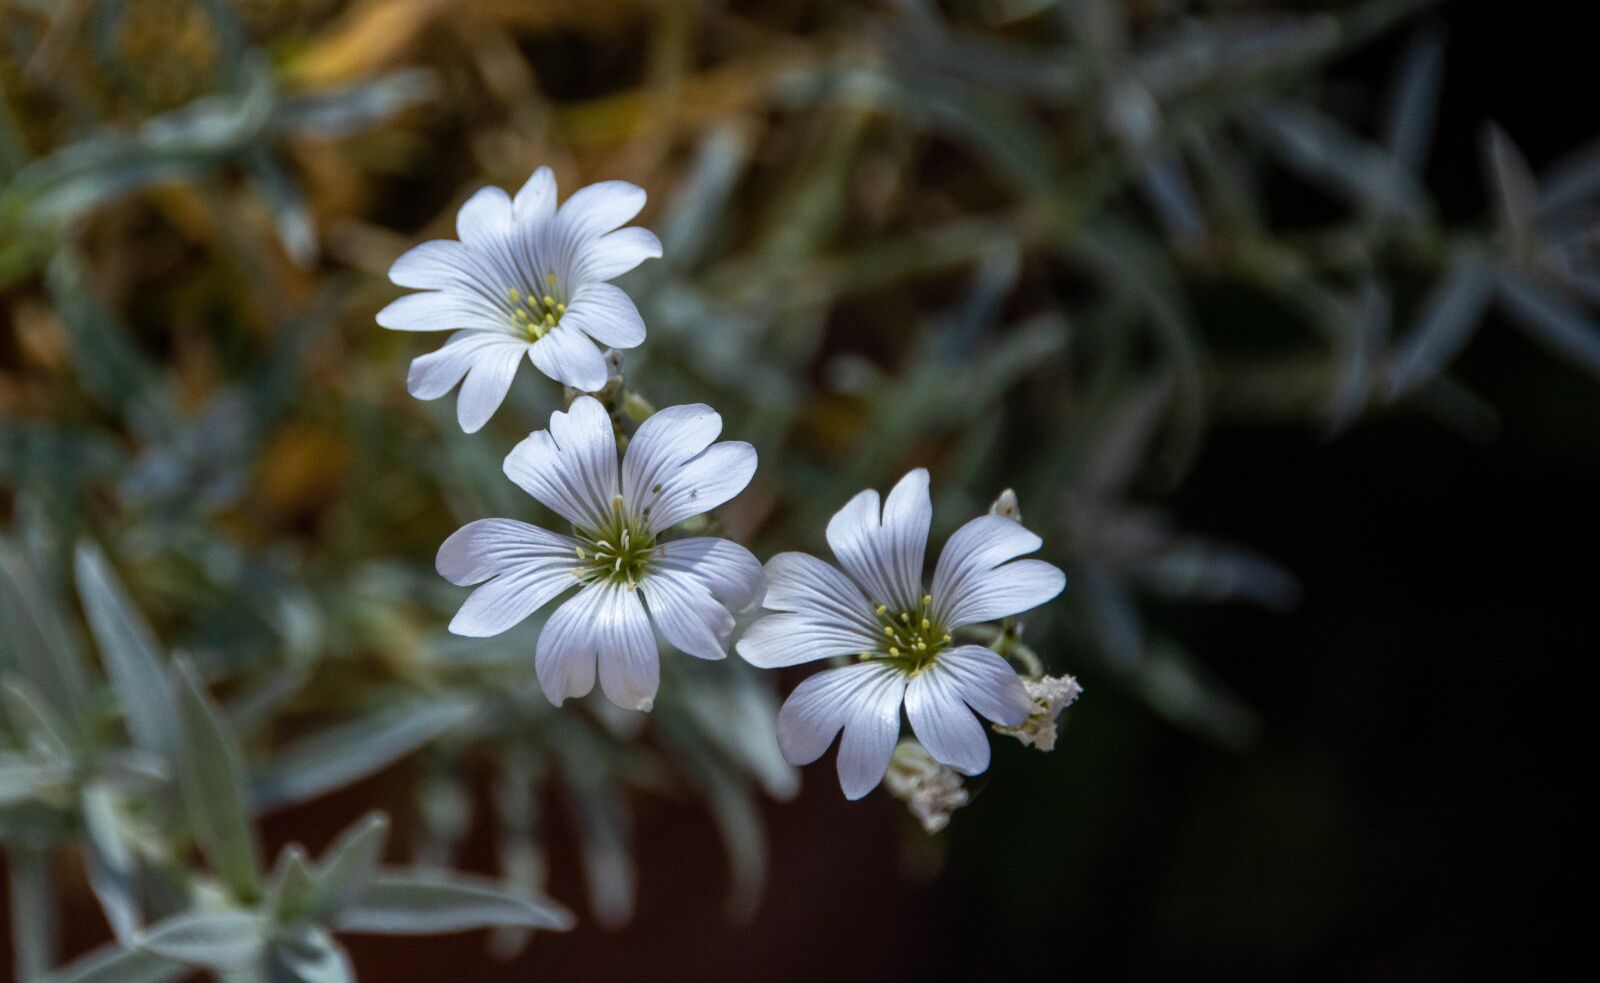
<box><xmin>0</xmin><ymin>0</ymin><xmax>1600</xmax><ymax>981</ymax></box>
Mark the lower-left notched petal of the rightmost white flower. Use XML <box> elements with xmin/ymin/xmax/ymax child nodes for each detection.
<box><xmin>778</xmin><ymin>663</ymin><xmax>906</xmax><ymax>799</ymax></box>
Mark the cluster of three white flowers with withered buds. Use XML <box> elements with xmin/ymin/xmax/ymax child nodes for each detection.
<box><xmin>378</xmin><ymin>168</ymin><xmax>1077</xmax><ymax>813</ymax></box>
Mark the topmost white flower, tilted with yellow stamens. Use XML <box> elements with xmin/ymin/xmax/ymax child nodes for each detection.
<box><xmin>378</xmin><ymin>167</ymin><xmax>661</xmax><ymax>434</ymax></box>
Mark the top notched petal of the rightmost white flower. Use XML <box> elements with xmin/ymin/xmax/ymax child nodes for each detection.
<box><xmin>827</xmin><ymin>467</ymin><xmax>933</xmax><ymax>610</ymax></box>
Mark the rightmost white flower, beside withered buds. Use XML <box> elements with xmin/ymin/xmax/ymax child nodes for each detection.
<box><xmin>739</xmin><ymin>467</ymin><xmax>1066</xmax><ymax>799</ymax></box>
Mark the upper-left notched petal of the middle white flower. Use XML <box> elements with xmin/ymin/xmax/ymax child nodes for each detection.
<box><xmin>506</xmin><ymin>395</ymin><xmax>618</xmax><ymax>530</ymax></box>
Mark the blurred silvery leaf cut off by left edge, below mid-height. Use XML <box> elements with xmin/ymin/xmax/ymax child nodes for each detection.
<box><xmin>0</xmin><ymin>536</ymin><xmax>90</xmax><ymax>720</ymax></box>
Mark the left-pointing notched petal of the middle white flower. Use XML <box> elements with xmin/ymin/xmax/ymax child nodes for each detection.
<box><xmin>435</xmin><ymin>519</ymin><xmax>578</xmax><ymax>637</ymax></box>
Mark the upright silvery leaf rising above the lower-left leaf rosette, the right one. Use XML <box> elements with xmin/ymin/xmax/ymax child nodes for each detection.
<box><xmin>173</xmin><ymin>660</ymin><xmax>261</xmax><ymax>901</ymax></box>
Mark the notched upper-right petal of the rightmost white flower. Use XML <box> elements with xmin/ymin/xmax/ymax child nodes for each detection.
<box><xmin>933</xmin><ymin>516</ymin><xmax>1067</xmax><ymax>628</ymax></box>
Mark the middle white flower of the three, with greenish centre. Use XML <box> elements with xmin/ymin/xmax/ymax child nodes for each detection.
<box><xmin>438</xmin><ymin>395</ymin><xmax>765</xmax><ymax>709</ymax></box>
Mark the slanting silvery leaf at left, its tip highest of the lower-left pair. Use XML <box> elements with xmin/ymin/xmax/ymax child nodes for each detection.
<box><xmin>75</xmin><ymin>541</ymin><xmax>176</xmax><ymax>754</ymax></box>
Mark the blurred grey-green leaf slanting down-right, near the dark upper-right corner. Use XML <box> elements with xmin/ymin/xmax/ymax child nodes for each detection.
<box><xmin>1250</xmin><ymin>104</ymin><xmax>1429</xmax><ymax>221</ymax></box>
